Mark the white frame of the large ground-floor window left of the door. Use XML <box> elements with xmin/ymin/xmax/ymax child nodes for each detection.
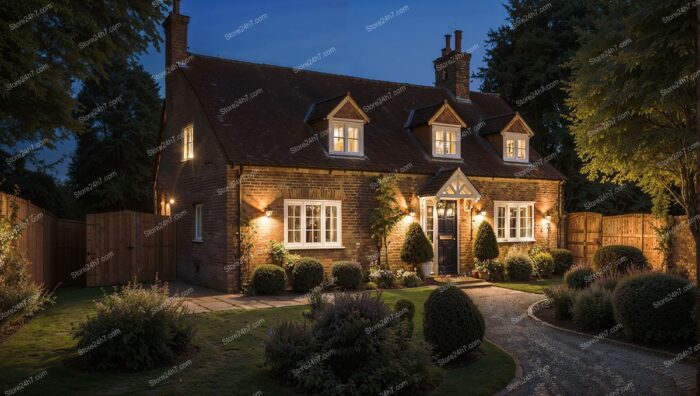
<box><xmin>284</xmin><ymin>199</ymin><xmax>343</xmax><ymax>250</ymax></box>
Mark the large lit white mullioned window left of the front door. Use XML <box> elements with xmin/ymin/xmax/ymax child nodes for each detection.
<box><xmin>284</xmin><ymin>199</ymin><xmax>342</xmax><ymax>249</ymax></box>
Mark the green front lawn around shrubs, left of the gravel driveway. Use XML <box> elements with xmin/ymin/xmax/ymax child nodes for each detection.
<box><xmin>0</xmin><ymin>288</ymin><xmax>515</xmax><ymax>395</ymax></box>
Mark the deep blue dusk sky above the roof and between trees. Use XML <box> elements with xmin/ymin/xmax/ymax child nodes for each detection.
<box><xmin>40</xmin><ymin>0</ymin><xmax>507</xmax><ymax>179</ymax></box>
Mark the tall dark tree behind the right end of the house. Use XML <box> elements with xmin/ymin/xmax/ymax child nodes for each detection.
<box><xmin>475</xmin><ymin>0</ymin><xmax>650</xmax><ymax>214</ymax></box>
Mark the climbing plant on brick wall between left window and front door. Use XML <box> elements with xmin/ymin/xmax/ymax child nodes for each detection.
<box><xmin>369</xmin><ymin>177</ymin><xmax>403</xmax><ymax>268</ymax></box>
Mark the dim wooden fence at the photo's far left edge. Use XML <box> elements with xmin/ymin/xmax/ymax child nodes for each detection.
<box><xmin>0</xmin><ymin>193</ymin><xmax>85</xmax><ymax>288</ymax></box>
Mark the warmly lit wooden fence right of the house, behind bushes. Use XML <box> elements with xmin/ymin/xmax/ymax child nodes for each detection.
<box><xmin>566</xmin><ymin>212</ymin><xmax>664</xmax><ymax>268</ymax></box>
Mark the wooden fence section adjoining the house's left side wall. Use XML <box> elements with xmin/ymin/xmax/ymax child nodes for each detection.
<box><xmin>85</xmin><ymin>211</ymin><xmax>175</xmax><ymax>286</ymax></box>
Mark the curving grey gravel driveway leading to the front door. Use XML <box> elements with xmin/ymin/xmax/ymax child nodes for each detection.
<box><xmin>467</xmin><ymin>287</ymin><xmax>696</xmax><ymax>396</ymax></box>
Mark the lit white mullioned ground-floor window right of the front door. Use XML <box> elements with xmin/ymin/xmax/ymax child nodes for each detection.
<box><xmin>494</xmin><ymin>201</ymin><xmax>535</xmax><ymax>242</ymax></box>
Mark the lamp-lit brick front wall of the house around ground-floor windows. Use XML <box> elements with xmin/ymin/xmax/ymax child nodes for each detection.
<box><xmin>228</xmin><ymin>167</ymin><xmax>558</xmax><ymax>288</ymax></box>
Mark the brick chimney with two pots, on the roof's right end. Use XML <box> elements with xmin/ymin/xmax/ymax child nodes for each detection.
<box><xmin>433</xmin><ymin>30</ymin><xmax>472</xmax><ymax>99</ymax></box>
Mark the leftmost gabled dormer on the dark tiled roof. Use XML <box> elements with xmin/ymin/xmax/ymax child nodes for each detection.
<box><xmin>306</xmin><ymin>92</ymin><xmax>369</xmax><ymax>157</ymax></box>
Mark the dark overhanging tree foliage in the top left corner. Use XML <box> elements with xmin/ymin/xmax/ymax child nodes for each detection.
<box><xmin>0</xmin><ymin>0</ymin><xmax>167</xmax><ymax>146</ymax></box>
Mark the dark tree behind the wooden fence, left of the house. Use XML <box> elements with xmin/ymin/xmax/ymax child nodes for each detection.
<box><xmin>70</xmin><ymin>61</ymin><xmax>161</xmax><ymax>212</ymax></box>
